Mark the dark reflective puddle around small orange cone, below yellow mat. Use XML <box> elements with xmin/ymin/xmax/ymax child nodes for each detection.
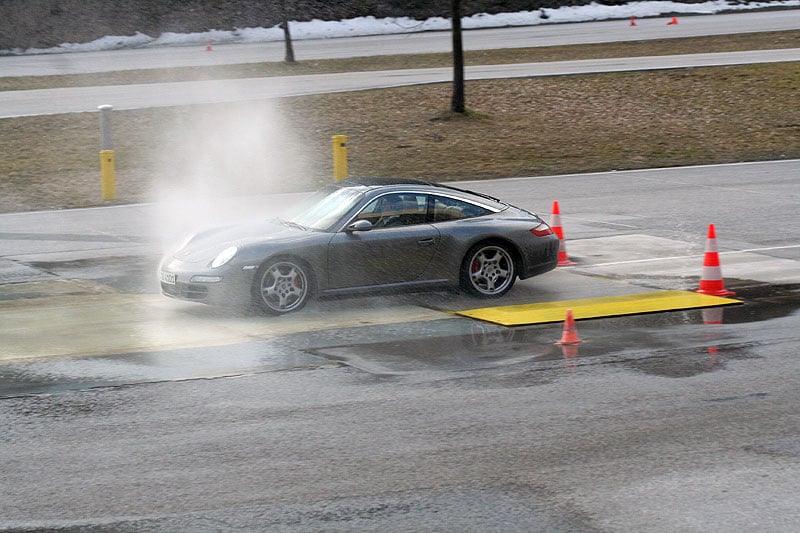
<box><xmin>312</xmin><ymin>285</ymin><xmax>800</xmax><ymax>378</ymax></box>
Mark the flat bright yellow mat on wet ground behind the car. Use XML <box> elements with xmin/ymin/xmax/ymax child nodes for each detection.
<box><xmin>455</xmin><ymin>291</ymin><xmax>742</xmax><ymax>326</ymax></box>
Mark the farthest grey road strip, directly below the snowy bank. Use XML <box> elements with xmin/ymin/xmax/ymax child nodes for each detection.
<box><xmin>0</xmin><ymin>9</ymin><xmax>800</xmax><ymax>76</ymax></box>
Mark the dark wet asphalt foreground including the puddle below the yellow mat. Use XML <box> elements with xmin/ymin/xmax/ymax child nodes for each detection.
<box><xmin>0</xmin><ymin>287</ymin><xmax>800</xmax><ymax>532</ymax></box>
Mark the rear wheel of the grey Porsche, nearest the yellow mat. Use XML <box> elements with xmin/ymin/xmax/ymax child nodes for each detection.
<box><xmin>461</xmin><ymin>241</ymin><xmax>517</xmax><ymax>298</ymax></box>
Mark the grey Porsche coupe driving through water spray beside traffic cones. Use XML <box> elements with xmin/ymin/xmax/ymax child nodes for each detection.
<box><xmin>159</xmin><ymin>178</ymin><xmax>558</xmax><ymax>314</ymax></box>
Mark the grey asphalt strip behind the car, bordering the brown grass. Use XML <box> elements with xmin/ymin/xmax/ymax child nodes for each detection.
<box><xmin>0</xmin><ymin>160</ymin><xmax>800</xmax><ymax>282</ymax></box>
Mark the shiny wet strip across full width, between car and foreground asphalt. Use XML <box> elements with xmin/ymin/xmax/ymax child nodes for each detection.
<box><xmin>0</xmin><ymin>285</ymin><xmax>800</xmax><ymax>397</ymax></box>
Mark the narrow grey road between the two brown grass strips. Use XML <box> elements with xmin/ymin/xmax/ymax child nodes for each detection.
<box><xmin>0</xmin><ymin>48</ymin><xmax>800</xmax><ymax>118</ymax></box>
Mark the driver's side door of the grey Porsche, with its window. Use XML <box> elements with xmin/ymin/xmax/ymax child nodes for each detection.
<box><xmin>327</xmin><ymin>193</ymin><xmax>441</xmax><ymax>289</ymax></box>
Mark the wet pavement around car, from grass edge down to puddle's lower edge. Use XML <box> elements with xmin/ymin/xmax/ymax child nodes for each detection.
<box><xmin>0</xmin><ymin>161</ymin><xmax>800</xmax><ymax>396</ymax></box>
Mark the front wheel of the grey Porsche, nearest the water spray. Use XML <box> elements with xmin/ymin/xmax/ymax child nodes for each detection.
<box><xmin>253</xmin><ymin>258</ymin><xmax>314</xmax><ymax>315</ymax></box>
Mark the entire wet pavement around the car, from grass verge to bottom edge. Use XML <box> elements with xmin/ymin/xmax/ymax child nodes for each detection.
<box><xmin>0</xmin><ymin>162</ymin><xmax>800</xmax><ymax>532</ymax></box>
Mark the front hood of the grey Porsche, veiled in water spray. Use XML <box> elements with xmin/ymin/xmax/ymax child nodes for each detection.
<box><xmin>173</xmin><ymin>221</ymin><xmax>311</xmax><ymax>263</ymax></box>
